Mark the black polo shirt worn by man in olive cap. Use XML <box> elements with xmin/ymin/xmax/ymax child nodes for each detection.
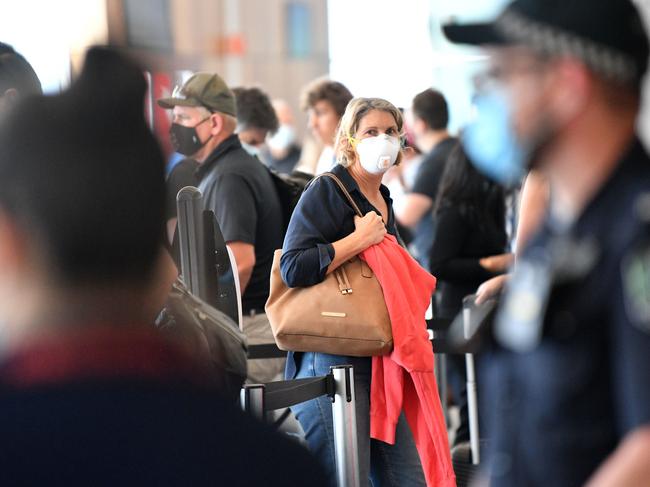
<box><xmin>197</xmin><ymin>135</ymin><xmax>283</xmax><ymax>313</ymax></box>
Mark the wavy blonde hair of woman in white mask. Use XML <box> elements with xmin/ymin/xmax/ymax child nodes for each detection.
<box><xmin>334</xmin><ymin>98</ymin><xmax>404</xmax><ymax>167</ymax></box>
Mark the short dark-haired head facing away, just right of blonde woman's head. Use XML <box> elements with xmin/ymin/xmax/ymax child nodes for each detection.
<box><xmin>412</xmin><ymin>88</ymin><xmax>449</xmax><ymax>152</ymax></box>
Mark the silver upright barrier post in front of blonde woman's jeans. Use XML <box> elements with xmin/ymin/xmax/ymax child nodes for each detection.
<box><xmin>330</xmin><ymin>365</ymin><xmax>361</xmax><ymax>487</ymax></box>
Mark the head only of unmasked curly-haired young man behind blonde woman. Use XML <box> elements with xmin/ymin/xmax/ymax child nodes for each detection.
<box><xmin>301</xmin><ymin>79</ymin><xmax>352</xmax><ymax>146</ymax></box>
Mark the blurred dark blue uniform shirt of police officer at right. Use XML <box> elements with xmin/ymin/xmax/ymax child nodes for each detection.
<box><xmin>481</xmin><ymin>140</ymin><xmax>650</xmax><ymax>487</ymax></box>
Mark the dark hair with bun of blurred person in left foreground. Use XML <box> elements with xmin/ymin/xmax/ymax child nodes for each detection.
<box><xmin>0</xmin><ymin>48</ymin><xmax>165</xmax><ymax>286</ymax></box>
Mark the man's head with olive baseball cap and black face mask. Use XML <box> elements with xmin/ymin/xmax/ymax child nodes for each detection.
<box><xmin>158</xmin><ymin>73</ymin><xmax>237</xmax><ymax>162</ymax></box>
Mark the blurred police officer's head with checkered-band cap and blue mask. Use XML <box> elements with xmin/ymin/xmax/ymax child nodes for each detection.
<box><xmin>445</xmin><ymin>0</ymin><xmax>648</xmax><ymax>187</ymax></box>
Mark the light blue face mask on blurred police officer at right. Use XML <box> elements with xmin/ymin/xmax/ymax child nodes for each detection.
<box><xmin>462</xmin><ymin>89</ymin><xmax>528</xmax><ymax>186</ymax></box>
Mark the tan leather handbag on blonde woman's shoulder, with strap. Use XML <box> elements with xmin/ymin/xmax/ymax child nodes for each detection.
<box><xmin>266</xmin><ymin>173</ymin><xmax>393</xmax><ymax>357</ymax></box>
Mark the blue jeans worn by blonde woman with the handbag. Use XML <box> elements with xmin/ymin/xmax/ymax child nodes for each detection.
<box><xmin>291</xmin><ymin>352</ymin><xmax>426</xmax><ymax>487</ymax></box>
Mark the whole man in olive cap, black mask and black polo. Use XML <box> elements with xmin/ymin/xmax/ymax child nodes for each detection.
<box><xmin>158</xmin><ymin>73</ymin><xmax>284</xmax><ymax>382</ymax></box>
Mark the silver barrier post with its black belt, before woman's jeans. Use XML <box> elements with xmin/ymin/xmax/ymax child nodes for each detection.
<box><xmin>241</xmin><ymin>365</ymin><xmax>360</xmax><ymax>487</ymax></box>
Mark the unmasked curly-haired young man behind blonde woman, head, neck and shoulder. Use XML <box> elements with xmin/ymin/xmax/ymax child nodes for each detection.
<box><xmin>300</xmin><ymin>78</ymin><xmax>352</xmax><ymax>175</ymax></box>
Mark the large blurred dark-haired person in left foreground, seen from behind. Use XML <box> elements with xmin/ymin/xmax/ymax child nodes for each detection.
<box><xmin>0</xmin><ymin>48</ymin><xmax>323</xmax><ymax>487</ymax></box>
